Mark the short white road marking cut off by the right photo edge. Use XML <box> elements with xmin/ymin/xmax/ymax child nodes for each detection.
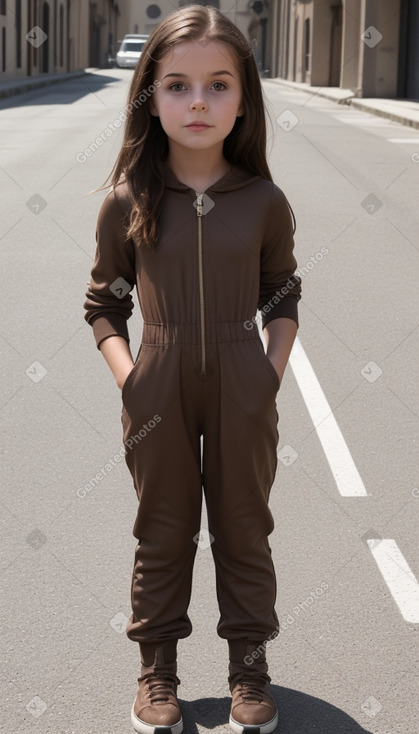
<box><xmin>367</xmin><ymin>538</ymin><xmax>419</xmax><ymax>624</ymax></box>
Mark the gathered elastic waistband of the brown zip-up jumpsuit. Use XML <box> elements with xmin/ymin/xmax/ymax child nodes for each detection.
<box><xmin>142</xmin><ymin>321</ymin><xmax>259</xmax><ymax>344</ymax></box>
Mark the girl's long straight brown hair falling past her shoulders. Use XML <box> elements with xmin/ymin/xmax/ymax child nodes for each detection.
<box><xmin>101</xmin><ymin>5</ymin><xmax>292</xmax><ymax>247</ymax></box>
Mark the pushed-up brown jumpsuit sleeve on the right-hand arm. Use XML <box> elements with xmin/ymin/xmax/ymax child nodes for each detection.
<box><xmin>258</xmin><ymin>184</ymin><xmax>301</xmax><ymax>327</ymax></box>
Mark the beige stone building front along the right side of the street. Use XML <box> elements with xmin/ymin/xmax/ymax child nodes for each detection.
<box><xmin>272</xmin><ymin>0</ymin><xmax>419</xmax><ymax>99</ymax></box>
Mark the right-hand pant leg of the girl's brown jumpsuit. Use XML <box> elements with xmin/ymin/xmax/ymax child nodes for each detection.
<box><xmin>203</xmin><ymin>340</ymin><xmax>279</xmax><ymax>640</ymax></box>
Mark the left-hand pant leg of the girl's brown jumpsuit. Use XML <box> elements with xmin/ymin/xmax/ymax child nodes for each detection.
<box><xmin>122</xmin><ymin>345</ymin><xmax>202</xmax><ymax>643</ymax></box>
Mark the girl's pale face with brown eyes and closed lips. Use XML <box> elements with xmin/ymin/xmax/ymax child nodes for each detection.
<box><xmin>150</xmin><ymin>41</ymin><xmax>243</xmax><ymax>155</ymax></box>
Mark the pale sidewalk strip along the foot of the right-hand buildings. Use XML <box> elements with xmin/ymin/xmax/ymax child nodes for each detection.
<box><xmin>263</xmin><ymin>78</ymin><xmax>419</xmax><ymax>130</ymax></box>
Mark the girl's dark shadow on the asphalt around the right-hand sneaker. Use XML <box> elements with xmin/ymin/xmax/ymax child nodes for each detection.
<box><xmin>179</xmin><ymin>684</ymin><xmax>371</xmax><ymax>734</ymax></box>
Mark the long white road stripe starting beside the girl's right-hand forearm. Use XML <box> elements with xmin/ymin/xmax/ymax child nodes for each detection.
<box><xmin>289</xmin><ymin>336</ymin><xmax>367</xmax><ymax>497</ymax></box>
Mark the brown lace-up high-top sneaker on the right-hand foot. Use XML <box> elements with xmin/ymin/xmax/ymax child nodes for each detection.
<box><xmin>228</xmin><ymin>640</ymin><xmax>278</xmax><ymax>734</ymax></box>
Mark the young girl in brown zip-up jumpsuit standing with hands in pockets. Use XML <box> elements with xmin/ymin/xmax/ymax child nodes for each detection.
<box><xmin>85</xmin><ymin>5</ymin><xmax>301</xmax><ymax>734</ymax></box>
